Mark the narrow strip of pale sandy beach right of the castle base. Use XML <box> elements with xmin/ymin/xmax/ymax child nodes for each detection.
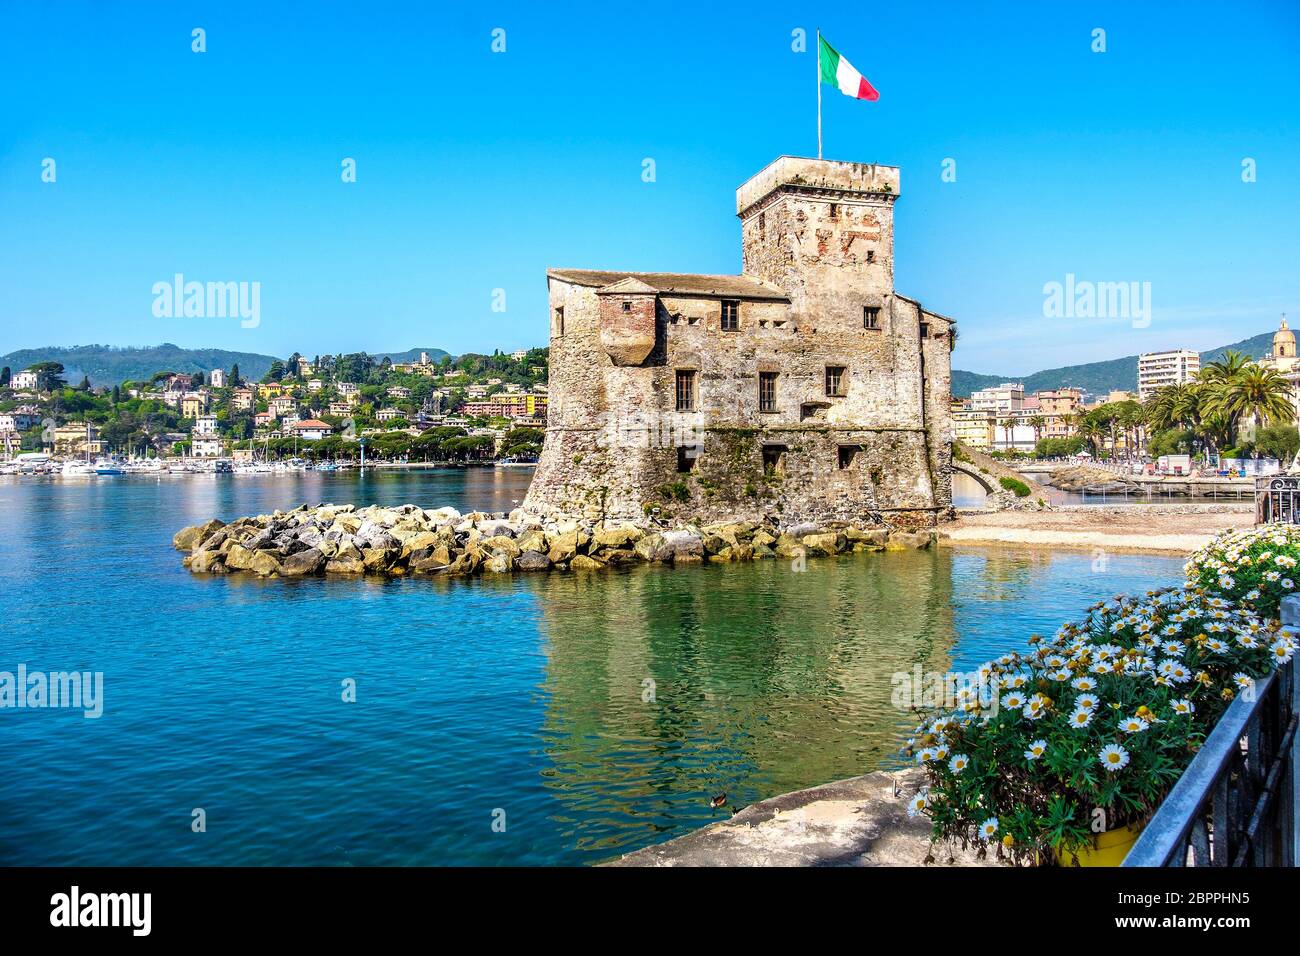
<box><xmin>939</xmin><ymin>502</ymin><xmax>1255</xmax><ymax>554</ymax></box>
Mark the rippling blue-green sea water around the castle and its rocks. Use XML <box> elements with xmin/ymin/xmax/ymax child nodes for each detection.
<box><xmin>0</xmin><ymin>468</ymin><xmax>1180</xmax><ymax>865</ymax></box>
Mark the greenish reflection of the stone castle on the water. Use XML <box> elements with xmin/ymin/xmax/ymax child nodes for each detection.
<box><xmin>532</xmin><ymin>550</ymin><xmax>954</xmax><ymax>858</ymax></box>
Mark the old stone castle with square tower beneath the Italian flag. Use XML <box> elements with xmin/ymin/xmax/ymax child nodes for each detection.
<box><xmin>524</xmin><ymin>156</ymin><xmax>954</xmax><ymax>528</ymax></box>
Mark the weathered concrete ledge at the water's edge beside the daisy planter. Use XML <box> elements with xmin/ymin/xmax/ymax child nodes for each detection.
<box><xmin>606</xmin><ymin>770</ymin><xmax>996</xmax><ymax>866</ymax></box>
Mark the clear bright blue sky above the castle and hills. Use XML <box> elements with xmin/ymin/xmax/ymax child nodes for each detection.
<box><xmin>0</xmin><ymin>0</ymin><xmax>1300</xmax><ymax>375</ymax></box>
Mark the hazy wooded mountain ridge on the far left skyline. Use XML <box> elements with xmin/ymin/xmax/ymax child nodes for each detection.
<box><xmin>0</xmin><ymin>342</ymin><xmax>274</xmax><ymax>385</ymax></box>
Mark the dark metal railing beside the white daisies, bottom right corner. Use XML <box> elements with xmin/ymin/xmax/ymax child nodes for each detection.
<box><xmin>1123</xmin><ymin>596</ymin><xmax>1300</xmax><ymax>866</ymax></box>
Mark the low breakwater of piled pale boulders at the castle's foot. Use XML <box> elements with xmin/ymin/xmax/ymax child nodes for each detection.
<box><xmin>172</xmin><ymin>505</ymin><xmax>933</xmax><ymax>578</ymax></box>
